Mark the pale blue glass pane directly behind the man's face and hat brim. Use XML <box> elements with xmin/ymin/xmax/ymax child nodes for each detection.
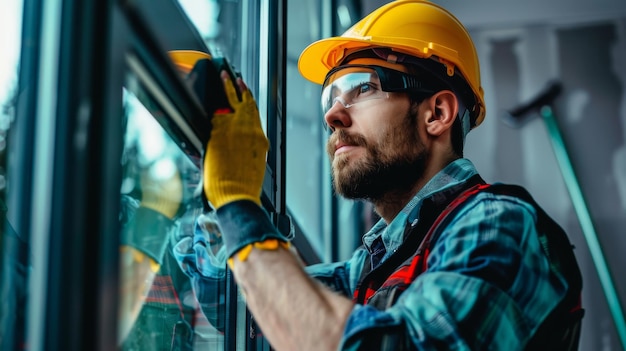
<box><xmin>286</xmin><ymin>0</ymin><xmax>369</xmax><ymax>261</ymax></box>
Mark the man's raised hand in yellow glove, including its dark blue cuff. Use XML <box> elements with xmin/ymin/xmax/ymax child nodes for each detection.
<box><xmin>204</xmin><ymin>72</ymin><xmax>288</xmax><ymax>258</ymax></box>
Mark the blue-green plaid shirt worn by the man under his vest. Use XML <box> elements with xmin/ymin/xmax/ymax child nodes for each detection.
<box><xmin>307</xmin><ymin>159</ymin><xmax>567</xmax><ymax>351</ymax></box>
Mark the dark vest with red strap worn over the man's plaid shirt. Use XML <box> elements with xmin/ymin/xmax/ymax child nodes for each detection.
<box><xmin>353</xmin><ymin>182</ymin><xmax>585</xmax><ymax>351</ymax></box>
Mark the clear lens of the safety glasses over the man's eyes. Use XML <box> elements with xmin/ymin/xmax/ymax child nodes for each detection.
<box><xmin>322</xmin><ymin>67</ymin><xmax>389</xmax><ymax>114</ymax></box>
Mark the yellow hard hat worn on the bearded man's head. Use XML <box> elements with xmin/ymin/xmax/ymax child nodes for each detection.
<box><xmin>298</xmin><ymin>0</ymin><xmax>485</xmax><ymax>126</ymax></box>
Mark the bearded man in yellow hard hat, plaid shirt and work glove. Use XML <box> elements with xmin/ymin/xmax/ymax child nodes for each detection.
<box><xmin>196</xmin><ymin>0</ymin><xmax>578</xmax><ymax>350</ymax></box>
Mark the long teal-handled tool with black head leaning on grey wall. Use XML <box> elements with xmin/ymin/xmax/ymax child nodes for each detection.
<box><xmin>508</xmin><ymin>82</ymin><xmax>626</xmax><ymax>350</ymax></box>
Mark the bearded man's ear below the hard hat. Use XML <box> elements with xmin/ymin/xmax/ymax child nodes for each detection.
<box><xmin>426</xmin><ymin>90</ymin><xmax>459</xmax><ymax>136</ymax></box>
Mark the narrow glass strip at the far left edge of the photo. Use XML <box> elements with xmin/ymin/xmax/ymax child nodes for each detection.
<box><xmin>0</xmin><ymin>0</ymin><xmax>28</xmax><ymax>350</ymax></box>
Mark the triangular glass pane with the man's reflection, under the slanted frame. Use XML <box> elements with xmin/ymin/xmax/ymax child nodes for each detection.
<box><xmin>119</xmin><ymin>77</ymin><xmax>226</xmax><ymax>350</ymax></box>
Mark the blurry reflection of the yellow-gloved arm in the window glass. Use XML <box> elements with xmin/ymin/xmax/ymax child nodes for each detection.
<box><xmin>119</xmin><ymin>104</ymin><xmax>183</xmax><ymax>341</ymax></box>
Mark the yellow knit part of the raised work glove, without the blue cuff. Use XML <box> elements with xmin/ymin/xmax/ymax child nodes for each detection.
<box><xmin>204</xmin><ymin>72</ymin><xmax>269</xmax><ymax>209</ymax></box>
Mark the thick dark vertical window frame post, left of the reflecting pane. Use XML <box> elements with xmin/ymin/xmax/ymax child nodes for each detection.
<box><xmin>19</xmin><ymin>0</ymin><xmax>122</xmax><ymax>350</ymax></box>
